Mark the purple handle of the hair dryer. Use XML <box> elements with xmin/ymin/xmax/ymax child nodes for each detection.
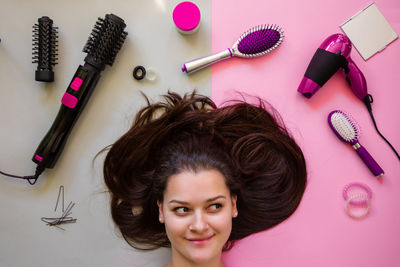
<box><xmin>345</xmin><ymin>57</ymin><xmax>368</xmax><ymax>100</ymax></box>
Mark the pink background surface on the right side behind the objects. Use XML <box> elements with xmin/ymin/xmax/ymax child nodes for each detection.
<box><xmin>211</xmin><ymin>0</ymin><xmax>400</xmax><ymax>267</ymax></box>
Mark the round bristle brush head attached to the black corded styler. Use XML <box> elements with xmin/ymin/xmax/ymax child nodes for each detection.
<box><xmin>83</xmin><ymin>14</ymin><xmax>128</xmax><ymax>69</ymax></box>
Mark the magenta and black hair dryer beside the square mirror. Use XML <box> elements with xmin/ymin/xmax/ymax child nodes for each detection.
<box><xmin>297</xmin><ymin>33</ymin><xmax>372</xmax><ymax>105</ymax></box>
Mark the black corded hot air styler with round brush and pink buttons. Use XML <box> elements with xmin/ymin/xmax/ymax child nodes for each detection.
<box><xmin>32</xmin><ymin>14</ymin><xmax>127</xmax><ymax>183</ymax></box>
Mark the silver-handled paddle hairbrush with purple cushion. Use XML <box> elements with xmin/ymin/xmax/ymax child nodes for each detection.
<box><xmin>182</xmin><ymin>25</ymin><xmax>283</xmax><ymax>73</ymax></box>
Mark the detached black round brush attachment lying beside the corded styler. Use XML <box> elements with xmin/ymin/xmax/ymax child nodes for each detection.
<box><xmin>32</xmin><ymin>16</ymin><xmax>58</xmax><ymax>82</ymax></box>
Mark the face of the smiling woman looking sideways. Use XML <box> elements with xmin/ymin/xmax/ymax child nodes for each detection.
<box><xmin>158</xmin><ymin>170</ymin><xmax>237</xmax><ymax>263</ymax></box>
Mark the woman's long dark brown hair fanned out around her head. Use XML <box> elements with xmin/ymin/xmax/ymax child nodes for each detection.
<box><xmin>103</xmin><ymin>92</ymin><xmax>306</xmax><ymax>249</ymax></box>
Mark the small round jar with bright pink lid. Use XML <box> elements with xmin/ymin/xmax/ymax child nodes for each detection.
<box><xmin>172</xmin><ymin>2</ymin><xmax>201</xmax><ymax>34</ymax></box>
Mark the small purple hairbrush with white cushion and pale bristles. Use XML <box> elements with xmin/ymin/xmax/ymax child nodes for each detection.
<box><xmin>328</xmin><ymin>110</ymin><xmax>384</xmax><ymax>178</ymax></box>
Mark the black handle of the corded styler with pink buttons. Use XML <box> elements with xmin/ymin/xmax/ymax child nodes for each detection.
<box><xmin>32</xmin><ymin>65</ymin><xmax>100</xmax><ymax>168</ymax></box>
